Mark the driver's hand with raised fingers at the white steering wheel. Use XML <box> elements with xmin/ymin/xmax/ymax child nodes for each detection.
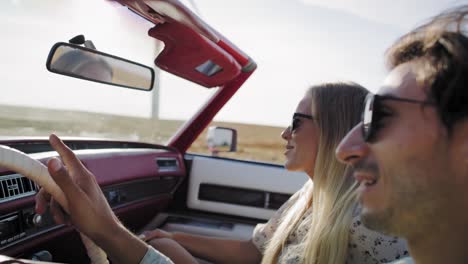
<box><xmin>36</xmin><ymin>134</ymin><xmax>118</xmax><ymax>239</ymax></box>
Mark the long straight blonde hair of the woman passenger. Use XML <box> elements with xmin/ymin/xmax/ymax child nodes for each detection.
<box><xmin>262</xmin><ymin>83</ymin><xmax>368</xmax><ymax>264</ymax></box>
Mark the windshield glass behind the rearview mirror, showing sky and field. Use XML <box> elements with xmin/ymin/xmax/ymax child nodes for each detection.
<box><xmin>0</xmin><ymin>0</ymin><xmax>216</xmax><ymax>144</ymax></box>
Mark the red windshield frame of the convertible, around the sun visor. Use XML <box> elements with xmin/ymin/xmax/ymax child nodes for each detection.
<box><xmin>115</xmin><ymin>0</ymin><xmax>257</xmax><ymax>153</ymax></box>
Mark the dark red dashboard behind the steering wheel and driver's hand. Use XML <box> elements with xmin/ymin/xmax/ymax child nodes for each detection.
<box><xmin>0</xmin><ymin>140</ymin><xmax>187</xmax><ymax>263</ymax></box>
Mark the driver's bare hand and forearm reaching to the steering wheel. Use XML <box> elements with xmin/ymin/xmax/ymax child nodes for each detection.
<box><xmin>36</xmin><ymin>135</ymin><xmax>172</xmax><ymax>264</ymax></box>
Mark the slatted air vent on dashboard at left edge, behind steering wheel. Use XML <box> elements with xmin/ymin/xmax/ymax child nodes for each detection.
<box><xmin>0</xmin><ymin>174</ymin><xmax>38</xmax><ymax>203</ymax></box>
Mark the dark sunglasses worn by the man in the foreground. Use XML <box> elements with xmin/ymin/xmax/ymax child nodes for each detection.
<box><xmin>362</xmin><ymin>93</ymin><xmax>435</xmax><ymax>142</ymax></box>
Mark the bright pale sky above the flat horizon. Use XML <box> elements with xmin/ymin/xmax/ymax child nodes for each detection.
<box><xmin>0</xmin><ymin>0</ymin><xmax>462</xmax><ymax>126</ymax></box>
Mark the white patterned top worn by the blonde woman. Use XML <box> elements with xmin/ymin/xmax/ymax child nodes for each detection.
<box><xmin>252</xmin><ymin>191</ymin><xmax>408</xmax><ymax>264</ymax></box>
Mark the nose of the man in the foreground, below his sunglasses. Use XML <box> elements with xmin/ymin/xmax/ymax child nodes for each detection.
<box><xmin>336</xmin><ymin>123</ymin><xmax>369</xmax><ymax>165</ymax></box>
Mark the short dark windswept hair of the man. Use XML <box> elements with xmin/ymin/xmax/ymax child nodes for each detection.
<box><xmin>387</xmin><ymin>5</ymin><xmax>468</xmax><ymax>132</ymax></box>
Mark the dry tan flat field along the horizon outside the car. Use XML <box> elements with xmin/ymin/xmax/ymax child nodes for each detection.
<box><xmin>0</xmin><ymin>105</ymin><xmax>285</xmax><ymax>164</ymax></box>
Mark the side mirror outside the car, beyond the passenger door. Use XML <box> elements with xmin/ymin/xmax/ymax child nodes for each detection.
<box><xmin>206</xmin><ymin>126</ymin><xmax>237</xmax><ymax>156</ymax></box>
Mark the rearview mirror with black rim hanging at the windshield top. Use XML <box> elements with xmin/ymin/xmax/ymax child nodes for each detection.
<box><xmin>46</xmin><ymin>42</ymin><xmax>155</xmax><ymax>91</ymax></box>
